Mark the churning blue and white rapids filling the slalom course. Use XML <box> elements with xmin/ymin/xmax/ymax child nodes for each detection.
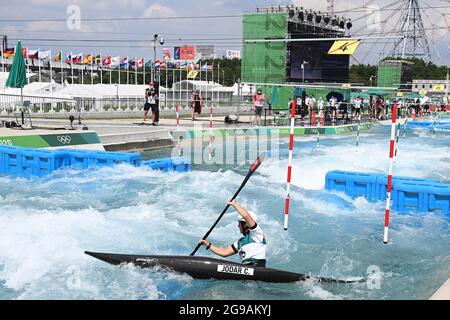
<box><xmin>0</xmin><ymin>127</ymin><xmax>450</xmax><ymax>299</ymax></box>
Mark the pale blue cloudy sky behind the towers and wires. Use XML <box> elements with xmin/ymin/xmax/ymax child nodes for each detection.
<box><xmin>0</xmin><ymin>0</ymin><xmax>450</xmax><ymax>65</ymax></box>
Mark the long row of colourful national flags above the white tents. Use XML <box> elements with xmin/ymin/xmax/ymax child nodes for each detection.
<box><xmin>0</xmin><ymin>48</ymin><xmax>213</xmax><ymax>71</ymax></box>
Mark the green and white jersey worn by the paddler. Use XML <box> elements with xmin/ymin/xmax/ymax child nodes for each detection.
<box><xmin>231</xmin><ymin>223</ymin><xmax>267</xmax><ymax>264</ymax></box>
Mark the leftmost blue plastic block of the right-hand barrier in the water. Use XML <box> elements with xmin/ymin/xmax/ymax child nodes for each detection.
<box><xmin>325</xmin><ymin>170</ymin><xmax>380</xmax><ymax>201</ymax></box>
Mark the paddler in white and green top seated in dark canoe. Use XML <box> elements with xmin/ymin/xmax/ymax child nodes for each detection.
<box><xmin>200</xmin><ymin>200</ymin><xmax>267</xmax><ymax>267</ymax></box>
